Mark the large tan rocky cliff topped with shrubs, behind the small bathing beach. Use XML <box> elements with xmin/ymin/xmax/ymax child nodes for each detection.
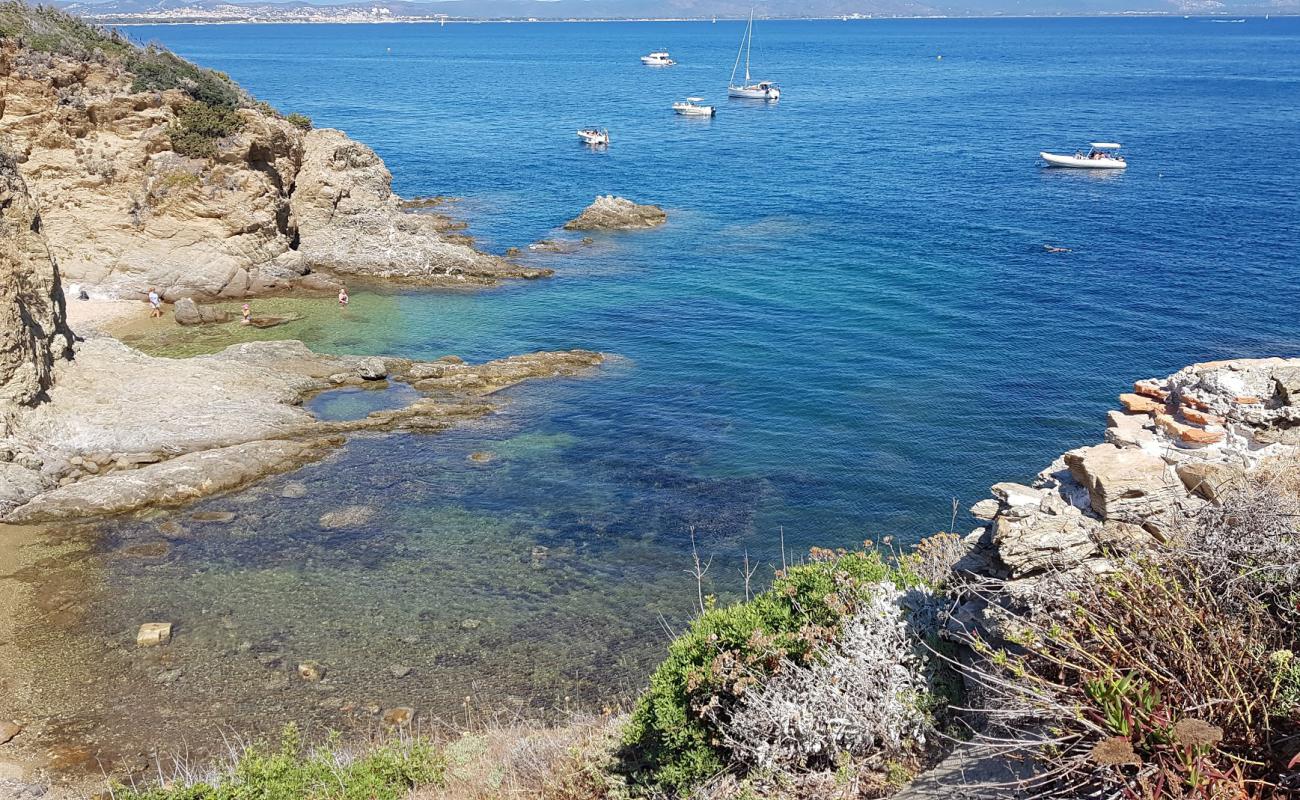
<box><xmin>0</xmin><ymin>3</ymin><xmax>547</xmax><ymax>299</ymax></box>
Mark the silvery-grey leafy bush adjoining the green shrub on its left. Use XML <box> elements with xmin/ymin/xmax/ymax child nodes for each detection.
<box><xmin>725</xmin><ymin>581</ymin><xmax>928</xmax><ymax>770</ymax></box>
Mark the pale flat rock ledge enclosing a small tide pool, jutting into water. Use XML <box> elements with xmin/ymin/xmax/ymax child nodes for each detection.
<box><xmin>0</xmin><ymin>337</ymin><xmax>605</xmax><ymax>523</ymax></box>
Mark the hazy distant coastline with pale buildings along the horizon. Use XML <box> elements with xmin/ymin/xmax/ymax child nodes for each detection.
<box><xmin>61</xmin><ymin>0</ymin><xmax>1300</xmax><ymax>22</ymax></box>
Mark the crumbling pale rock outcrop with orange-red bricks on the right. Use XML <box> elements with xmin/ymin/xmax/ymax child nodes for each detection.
<box><xmin>953</xmin><ymin>358</ymin><xmax>1300</xmax><ymax>635</ymax></box>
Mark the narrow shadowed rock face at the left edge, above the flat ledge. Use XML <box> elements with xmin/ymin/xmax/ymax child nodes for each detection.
<box><xmin>0</xmin><ymin>152</ymin><xmax>72</xmax><ymax>426</ymax></box>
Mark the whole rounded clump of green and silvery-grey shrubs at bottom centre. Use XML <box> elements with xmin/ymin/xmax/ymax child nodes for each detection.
<box><xmin>624</xmin><ymin>550</ymin><xmax>952</xmax><ymax>796</ymax></box>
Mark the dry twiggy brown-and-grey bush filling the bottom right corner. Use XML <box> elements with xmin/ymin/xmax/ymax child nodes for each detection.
<box><xmin>946</xmin><ymin>473</ymin><xmax>1300</xmax><ymax>800</ymax></box>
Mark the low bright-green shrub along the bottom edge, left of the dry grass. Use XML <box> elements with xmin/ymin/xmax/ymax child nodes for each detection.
<box><xmin>113</xmin><ymin>726</ymin><xmax>445</xmax><ymax>800</ymax></box>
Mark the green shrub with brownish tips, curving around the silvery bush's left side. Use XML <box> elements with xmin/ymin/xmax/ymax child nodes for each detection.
<box><xmin>623</xmin><ymin>550</ymin><xmax>918</xmax><ymax>795</ymax></box>
